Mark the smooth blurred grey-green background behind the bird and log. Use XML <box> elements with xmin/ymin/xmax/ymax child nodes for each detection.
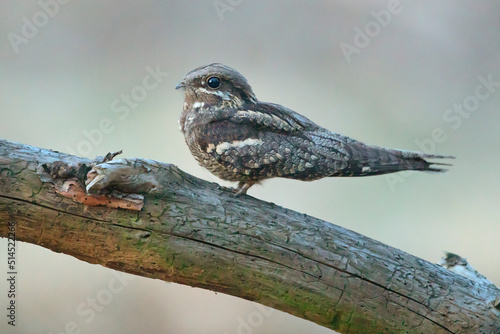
<box><xmin>0</xmin><ymin>0</ymin><xmax>500</xmax><ymax>334</ymax></box>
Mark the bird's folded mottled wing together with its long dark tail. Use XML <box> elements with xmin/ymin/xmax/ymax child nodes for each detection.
<box><xmin>200</xmin><ymin>103</ymin><xmax>454</xmax><ymax>180</ymax></box>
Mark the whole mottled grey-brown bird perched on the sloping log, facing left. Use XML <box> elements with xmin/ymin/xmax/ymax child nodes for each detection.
<box><xmin>175</xmin><ymin>63</ymin><xmax>453</xmax><ymax>194</ymax></box>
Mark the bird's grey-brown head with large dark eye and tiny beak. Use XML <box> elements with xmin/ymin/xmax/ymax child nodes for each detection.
<box><xmin>175</xmin><ymin>63</ymin><xmax>257</xmax><ymax>108</ymax></box>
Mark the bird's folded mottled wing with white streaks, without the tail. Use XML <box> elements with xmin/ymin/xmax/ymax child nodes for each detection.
<box><xmin>195</xmin><ymin>102</ymin><xmax>348</xmax><ymax>180</ymax></box>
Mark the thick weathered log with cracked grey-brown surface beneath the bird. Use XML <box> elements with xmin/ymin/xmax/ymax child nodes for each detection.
<box><xmin>0</xmin><ymin>140</ymin><xmax>500</xmax><ymax>334</ymax></box>
